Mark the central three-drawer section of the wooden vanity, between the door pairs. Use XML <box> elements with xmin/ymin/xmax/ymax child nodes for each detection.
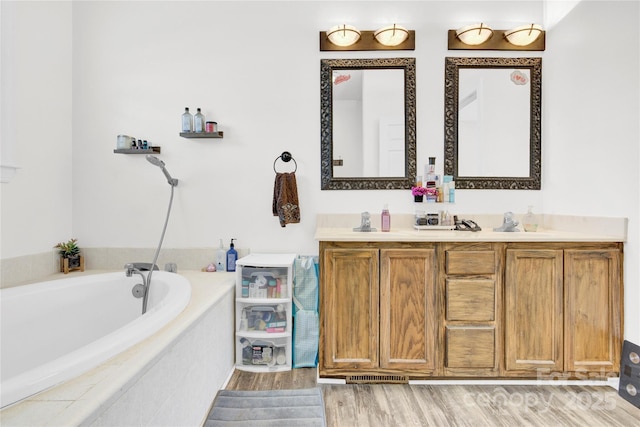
<box><xmin>439</xmin><ymin>243</ymin><xmax>502</xmax><ymax>377</ymax></box>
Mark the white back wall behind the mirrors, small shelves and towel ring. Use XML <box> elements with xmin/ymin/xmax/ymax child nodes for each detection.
<box><xmin>65</xmin><ymin>2</ymin><xmax>542</xmax><ymax>253</ymax></box>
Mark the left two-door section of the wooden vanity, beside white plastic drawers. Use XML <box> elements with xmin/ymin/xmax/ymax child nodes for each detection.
<box><xmin>319</xmin><ymin>242</ymin><xmax>438</xmax><ymax>377</ymax></box>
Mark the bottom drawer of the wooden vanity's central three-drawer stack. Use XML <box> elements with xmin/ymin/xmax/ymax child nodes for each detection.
<box><xmin>446</xmin><ymin>327</ymin><xmax>496</xmax><ymax>368</ymax></box>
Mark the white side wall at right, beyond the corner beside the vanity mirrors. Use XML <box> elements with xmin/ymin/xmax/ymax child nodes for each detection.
<box><xmin>542</xmin><ymin>1</ymin><xmax>640</xmax><ymax>343</ymax></box>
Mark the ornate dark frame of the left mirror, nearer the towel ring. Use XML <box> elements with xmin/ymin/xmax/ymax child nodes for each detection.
<box><xmin>320</xmin><ymin>58</ymin><xmax>416</xmax><ymax>190</ymax></box>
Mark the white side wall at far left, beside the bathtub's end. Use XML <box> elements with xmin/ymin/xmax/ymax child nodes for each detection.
<box><xmin>0</xmin><ymin>1</ymin><xmax>76</xmax><ymax>259</ymax></box>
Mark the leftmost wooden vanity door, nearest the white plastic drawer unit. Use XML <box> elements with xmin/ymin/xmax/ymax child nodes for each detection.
<box><xmin>320</xmin><ymin>248</ymin><xmax>379</xmax><ymax>374</ymax></box>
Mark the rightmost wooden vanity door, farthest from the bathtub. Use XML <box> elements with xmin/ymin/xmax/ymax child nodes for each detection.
<box><xmin>564</xmin><ymin>249</ymin><xmax>622</xmax><ymax>376</ymax></box>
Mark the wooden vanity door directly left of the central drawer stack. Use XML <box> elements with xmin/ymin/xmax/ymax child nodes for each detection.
<box><xmin>380</xmin><ymin>248</ymin><xmax>437</xmax><ymax>374</ymax></box>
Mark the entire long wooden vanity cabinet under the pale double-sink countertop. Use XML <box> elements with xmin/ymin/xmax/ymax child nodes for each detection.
<box><xmin>318</xmin><ymin>241</ymin><xmax>623</xmax><ymax>382</ymax></box>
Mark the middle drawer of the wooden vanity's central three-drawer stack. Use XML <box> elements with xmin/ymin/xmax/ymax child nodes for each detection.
<box><xmin>446</xmin><ymin>279</ymin><xmax>496</xmax><ymax>321</ymax></box>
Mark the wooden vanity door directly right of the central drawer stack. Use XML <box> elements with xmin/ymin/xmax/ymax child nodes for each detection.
<box><xmin>504</xmin><ymin>249</ymin><xmax>563</xmax><ymax>375</ymax></box>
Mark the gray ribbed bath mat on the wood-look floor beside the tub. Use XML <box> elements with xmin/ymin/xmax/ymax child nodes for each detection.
<box><xmin>204</xmin><ymin>387</ymin><xmax>326</xmax><ymax>427</ymax></box>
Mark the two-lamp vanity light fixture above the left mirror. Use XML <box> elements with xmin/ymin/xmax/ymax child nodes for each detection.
<box><xmin>320</xmin><ymin>24</ymin><xmax>416</xmax><ymax>51</ymax></box>
